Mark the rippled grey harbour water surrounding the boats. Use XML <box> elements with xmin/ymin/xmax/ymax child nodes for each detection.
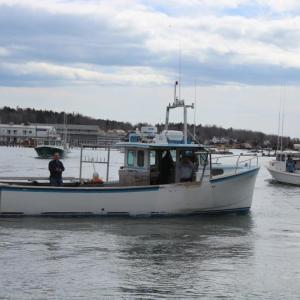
<box><xmin>0</xmin><ymin>147</ymin><xmax>300</xmax><ymax>299</ymax></box>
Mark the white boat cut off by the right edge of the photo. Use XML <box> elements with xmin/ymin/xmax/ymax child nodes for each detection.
<box><xmin>266</xmin><ymin>151</ymin><xmax>300</xmax><ymax>185</ymax></box>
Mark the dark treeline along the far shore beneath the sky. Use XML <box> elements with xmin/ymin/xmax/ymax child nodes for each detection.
<box><xmin>0</xmin><ymin>106</ymin><xmax>300</xmax><ymax>149</ymax></box>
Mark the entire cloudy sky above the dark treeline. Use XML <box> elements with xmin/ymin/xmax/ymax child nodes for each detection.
<box><xmin>0</xmin><ymin>0</ymin><xmax>300</xmax><ymax>137</ymax></box>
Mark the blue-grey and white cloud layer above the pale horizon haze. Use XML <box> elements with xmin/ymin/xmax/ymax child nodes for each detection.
<box><xmin>0</xmin><ymin>0</ymin><xmax>300</xmax><ymax>86</ymax></box>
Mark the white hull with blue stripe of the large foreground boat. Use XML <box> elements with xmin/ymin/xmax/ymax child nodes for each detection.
<box><xmin>0</xmin><ymin>168</ymin><xmax>259</xmax><ymax>216</ymax></box>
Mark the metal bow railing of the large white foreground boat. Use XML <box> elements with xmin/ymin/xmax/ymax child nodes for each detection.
<box><xmin>211</xmin><ymin>153</ymin><xmax>259</xmax><ymax>177</ymax></box>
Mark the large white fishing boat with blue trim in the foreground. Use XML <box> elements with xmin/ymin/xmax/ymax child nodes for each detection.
<box><xmin>0</xmin><ymin>85</ymin><xmax>259</xmax><ymax>216</ymax></box>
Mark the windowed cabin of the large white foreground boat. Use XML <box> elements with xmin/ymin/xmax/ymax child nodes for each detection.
<box><xmin>118</xmin><ymin>138</ymin><xmax>209</xmax><ymax>186</ymax></box>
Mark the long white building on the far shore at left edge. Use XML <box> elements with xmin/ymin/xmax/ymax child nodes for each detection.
<box><xmin>0</xmin><ymin>124</ymin><xmax>57</xmax><ymax>144</ymax></box>
